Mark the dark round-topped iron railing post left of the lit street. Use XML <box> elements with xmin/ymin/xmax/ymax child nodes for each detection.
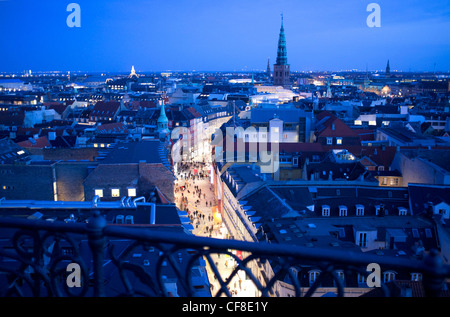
<box><xmin>87</xmin><ymin>210</ymin><xmax>106</xmax><ymax>297</ymax></box>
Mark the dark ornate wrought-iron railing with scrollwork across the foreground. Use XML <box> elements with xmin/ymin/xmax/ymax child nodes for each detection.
<box><xmin>0</xmin><ymin>212</ymin><xmax>450</xmax><ymax>297</ymax></box>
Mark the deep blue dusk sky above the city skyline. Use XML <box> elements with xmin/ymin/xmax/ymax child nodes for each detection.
<box><xmin>0</xmin><ymin>0</ymin><xmax>450</xmax><ymax>72</ymax></box>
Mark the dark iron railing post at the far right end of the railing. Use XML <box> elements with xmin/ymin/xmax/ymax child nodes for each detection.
<box><xmin>423</xmin><ymin>249</ymin><xmax>444</xmax><ymax>297</ymax></box>
